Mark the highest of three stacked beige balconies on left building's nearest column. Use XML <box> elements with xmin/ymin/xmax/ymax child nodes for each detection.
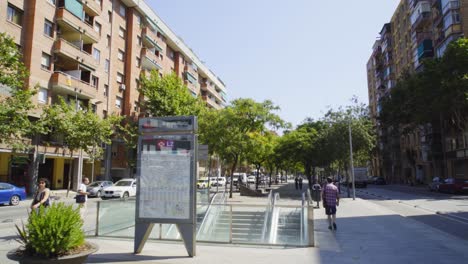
<box><xmin>55</xmin><ymin>8</ymin><xmax>100</xmax><ymax>44</ymax></box>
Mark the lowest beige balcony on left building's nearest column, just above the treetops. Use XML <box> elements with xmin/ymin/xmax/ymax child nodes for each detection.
<box><xmin>51</xmin><ymin>72</ymin><xmax>98</xmax><ymax>99</ymax></box>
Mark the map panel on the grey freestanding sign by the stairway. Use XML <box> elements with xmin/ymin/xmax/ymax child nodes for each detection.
<box><xmin>139</xmin><ymin>135</ymin><xmax>193</xmax><ymax>219</ymax></box>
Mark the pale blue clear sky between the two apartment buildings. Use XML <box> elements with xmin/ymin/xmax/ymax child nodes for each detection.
<box><xmin>146</xmin><ymin>0</ymin><xmax>399</xmax><ymax>127</ymax></box>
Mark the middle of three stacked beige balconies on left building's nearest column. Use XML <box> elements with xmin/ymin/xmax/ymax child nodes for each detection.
<box><xmin>54</xmin><ymin>38</ymin><xmax>98</xmax><ymax>70</ymax></box>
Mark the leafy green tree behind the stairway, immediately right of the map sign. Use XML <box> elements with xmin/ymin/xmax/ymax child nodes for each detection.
<box><xmin>201</xmin><ymin>99</ymin><xmax>288</xmax><ymax>198</ymax></box>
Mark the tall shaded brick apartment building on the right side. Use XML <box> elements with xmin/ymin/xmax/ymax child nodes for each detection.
<box><xmin>367</xmin><ymin>0</ymin><xmax>468</xmax><ymax>183</ymax></box>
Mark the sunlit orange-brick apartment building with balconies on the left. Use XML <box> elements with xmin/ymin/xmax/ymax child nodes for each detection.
<box><xmin>0</xmin><ymin>0</ymin><xmax>227</xmax><ymax>188</ymax></box>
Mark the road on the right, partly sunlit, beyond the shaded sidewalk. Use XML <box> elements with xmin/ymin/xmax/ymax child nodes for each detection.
<box><xmin>356</xmin><ymin>185</ymin><xmax>468</xmax><ymax>240</ymax></box>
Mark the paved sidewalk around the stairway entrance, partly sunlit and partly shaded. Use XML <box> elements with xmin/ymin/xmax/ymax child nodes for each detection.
<box><xmin>0</xmin><ymin>184</ymin><xmax>468</xmax><ymax>264</ymax></box>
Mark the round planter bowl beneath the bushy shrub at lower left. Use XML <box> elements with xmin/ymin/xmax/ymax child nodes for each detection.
<box><xmin>7</xmin><ymin>242</ymin><xmax>99</xmax><ymax>264</ymax></box>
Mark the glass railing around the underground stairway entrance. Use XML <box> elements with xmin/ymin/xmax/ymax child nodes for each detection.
<box><xmin>96</xmin><ymin>193</ymin><xmax>313</xmax><ymax>246</ymax></box>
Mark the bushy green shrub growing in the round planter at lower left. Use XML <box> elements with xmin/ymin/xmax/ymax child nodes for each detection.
<box><xmin>16</xmin><ymin>202</ymin><xmax>89</xmax><ymax>258</ymax></box>
